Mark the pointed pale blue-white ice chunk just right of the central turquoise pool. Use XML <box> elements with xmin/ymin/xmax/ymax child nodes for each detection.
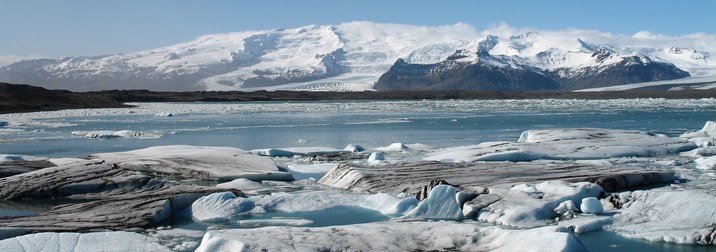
<box><xmin>403</xmin><ymin>185</ymin><xmax>463</xmax><ymax>220</ymax></box>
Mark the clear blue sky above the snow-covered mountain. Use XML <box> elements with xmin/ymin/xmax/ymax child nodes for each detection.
<box><xmin>0</xmin><ymin>0</ymin><xmax>716</xmax><ymax>57</ymax></box>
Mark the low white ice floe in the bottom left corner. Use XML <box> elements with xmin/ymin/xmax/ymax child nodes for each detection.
<box><xmin>0</xmin><ymin>232</ymin><xmax>170</xmax><ymax>252</ymax></box>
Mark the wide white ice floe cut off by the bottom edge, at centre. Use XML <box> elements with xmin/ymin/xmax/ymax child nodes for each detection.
<box><xmin>196</xmin><ymin>222</ymin><xmax>586</xmax><ymax>252</ymax></box>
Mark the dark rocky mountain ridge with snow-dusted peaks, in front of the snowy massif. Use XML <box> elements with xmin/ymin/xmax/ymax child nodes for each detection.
<box><xmin>374</xmin><ymin>51</ymin><xmax>690</xmax><ymax>92</ymax></box>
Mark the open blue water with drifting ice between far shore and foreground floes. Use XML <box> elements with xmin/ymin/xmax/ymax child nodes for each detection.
<box><xmin>0</xmin><ymin>99</ymin><xmax>716</xmax><ymax>157</ymax></box>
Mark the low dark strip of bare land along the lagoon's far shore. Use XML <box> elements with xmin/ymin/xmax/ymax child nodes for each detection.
<box><xmin>0</xmin><ymin>83</ymin><xmax>716</xmax><ymax>114</ymax></box>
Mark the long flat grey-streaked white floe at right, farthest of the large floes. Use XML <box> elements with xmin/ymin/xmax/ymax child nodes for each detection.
<box><xmin>425</xmin><ymin>128</ymin><xmax>697</xmax><ymax>162</ymax></box>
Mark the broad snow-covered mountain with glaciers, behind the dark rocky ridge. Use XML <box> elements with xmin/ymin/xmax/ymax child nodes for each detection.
<box><xmin>0</xmin><ymin>22</ymin><xmax>716</xmax><ymax>91</ymax></box>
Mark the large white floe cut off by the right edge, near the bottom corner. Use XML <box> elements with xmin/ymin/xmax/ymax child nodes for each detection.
<box><xmin>606</xmin><ymin>189</ymin><xmax>716</xmax><ymax>244</ymax></box>
